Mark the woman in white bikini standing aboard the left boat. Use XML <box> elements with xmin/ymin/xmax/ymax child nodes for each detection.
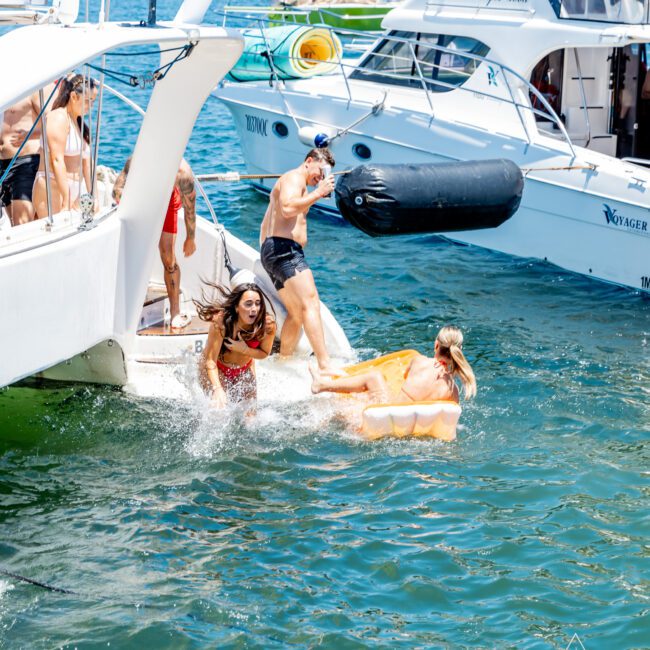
<box><xmin>32</xmin><ymin>74</ymin><xmax>97</xmax><ymax>219</ymax></box>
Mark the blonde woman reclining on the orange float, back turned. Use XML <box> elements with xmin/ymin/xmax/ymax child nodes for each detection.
<box><xmin>309</xmin><ymin>326</ymin><xmax>476</xmax><ymax>404</ymax></box>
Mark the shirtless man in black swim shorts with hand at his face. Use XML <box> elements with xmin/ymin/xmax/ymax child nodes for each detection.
<box><xmin>260</xmin><ymin>149</ymin><xmax>334</xmax><ymax>373</ymax></box>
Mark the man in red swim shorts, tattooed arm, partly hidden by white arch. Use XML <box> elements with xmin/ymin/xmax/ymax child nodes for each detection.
<box><xmin>113</xmin><ymin>157</ymin><xmax>196</xmax><ymax>329</ymax></box>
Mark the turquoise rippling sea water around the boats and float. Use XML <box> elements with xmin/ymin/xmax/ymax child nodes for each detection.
<box><xmin>0</xmin><ymin>6</ymin><xmax>650</xmax><ymax>650</ymax></box>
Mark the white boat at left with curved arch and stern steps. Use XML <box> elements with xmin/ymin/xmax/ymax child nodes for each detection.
<box><xmin>0</xmin><ymin>0</ymin><xmax>349</xmax><ymax>394</ymax></box>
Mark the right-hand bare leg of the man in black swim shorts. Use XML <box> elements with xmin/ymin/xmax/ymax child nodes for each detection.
<box><xmin>280</xmin><ymin>269</ymin><xmax>331</xmax><ymax>371</ymax></box>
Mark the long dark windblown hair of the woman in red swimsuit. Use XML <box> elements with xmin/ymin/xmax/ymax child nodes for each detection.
<box><xmin>192</xmin><ymin>280</ymin><xmax>275</xmax><ymax>341</ymax></box>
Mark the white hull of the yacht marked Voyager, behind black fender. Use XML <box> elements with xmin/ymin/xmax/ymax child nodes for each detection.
<box><xmin>215</xmin><ymin>89</ymin><xmax>650</xmax><ymax>291</ymax></box>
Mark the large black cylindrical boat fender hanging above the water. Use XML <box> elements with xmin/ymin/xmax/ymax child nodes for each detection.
<box><xmin>336</xmin><ymin>158</ymin><xmax>524</xmax><ymax>236</ymax></box>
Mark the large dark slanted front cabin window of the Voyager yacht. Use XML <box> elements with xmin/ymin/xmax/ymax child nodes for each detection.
<box><xmin>350</xmin><ymin>32</ymin><xmax>489</xmax><ymax>92</ymax></box>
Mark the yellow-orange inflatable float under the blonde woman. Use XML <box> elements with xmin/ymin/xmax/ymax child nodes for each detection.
<box><xmin>345</xmin><ymin>350</ymin><xmax>461</xmax><ymax>440</ymax></box>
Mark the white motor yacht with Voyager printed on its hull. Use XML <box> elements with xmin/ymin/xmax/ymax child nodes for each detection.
<box><xmin>215</xmin><ymin>0</ymin><xmax>650</xmax><ymax>290</ymax></box>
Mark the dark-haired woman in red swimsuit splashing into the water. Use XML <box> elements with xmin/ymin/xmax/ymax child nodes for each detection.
<box><xmin>194</xmin><ymin>283</ymin><xmax>276</xmax><ymax>408</ymax></box>
